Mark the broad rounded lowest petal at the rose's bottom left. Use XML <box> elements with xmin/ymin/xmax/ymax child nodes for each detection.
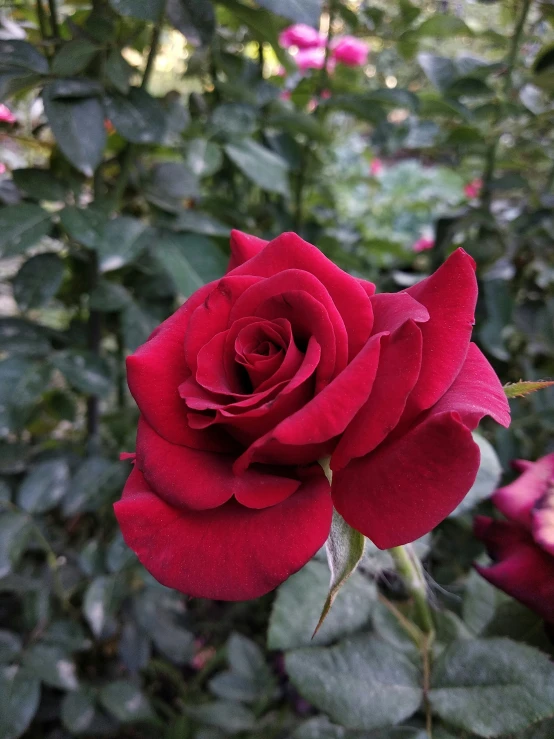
<box><xmin>114</xmin><ymin>468</ymin><xmax>332</xmax><ymax>600</ymax></box>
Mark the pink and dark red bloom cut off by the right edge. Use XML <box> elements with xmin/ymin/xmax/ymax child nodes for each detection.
<box><xmin>475</xmin><ymin>454</ymin><xmax>554</xmax><ymax>623</ymax></box>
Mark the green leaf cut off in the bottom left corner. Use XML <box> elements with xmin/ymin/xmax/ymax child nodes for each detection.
<box><xmin>0</xmin><ymin>667</ymin><xmax>40</xmax><ymax>739</ymax></box>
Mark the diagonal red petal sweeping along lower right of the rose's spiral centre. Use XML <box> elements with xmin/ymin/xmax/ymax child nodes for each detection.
<box><xmin>236</xmin><ymin>334</ymin><xmax>385</xmax><ymax>471</ymax></box>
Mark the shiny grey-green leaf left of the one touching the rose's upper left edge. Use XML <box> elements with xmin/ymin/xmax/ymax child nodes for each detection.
<box><xmin>97</xmin><ymin>216</ymin><xmax>147</xmax><ymax>272</ymax></box>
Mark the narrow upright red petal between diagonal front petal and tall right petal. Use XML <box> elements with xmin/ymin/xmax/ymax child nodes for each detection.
<box><xmin>331</xmin><ymin>320</ymin><xmax>422</xmax><ymax>472</ymax></box>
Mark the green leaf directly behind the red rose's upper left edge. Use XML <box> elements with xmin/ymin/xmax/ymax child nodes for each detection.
<box><xmin>152</xmin><ymin>230</ymin><xmax>227</xmax><ymax>297</ymax></box>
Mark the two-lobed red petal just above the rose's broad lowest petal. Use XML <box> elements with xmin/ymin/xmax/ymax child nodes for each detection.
<box><xmin>137</xmin><ymin>419</ymin><xmax>300</xmax><ymax>510</ymax></box>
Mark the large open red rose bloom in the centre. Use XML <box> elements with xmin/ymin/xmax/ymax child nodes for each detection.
<box><xmin>116</xmin><ymin>232</ymin><xmax>509</xmax><ymax>600</ymax></box>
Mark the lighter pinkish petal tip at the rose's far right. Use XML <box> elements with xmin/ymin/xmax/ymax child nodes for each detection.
<box><xmin>426</xmin><ymin>344</ymin><xmax>510</xmax><ymax>429</ymax></box>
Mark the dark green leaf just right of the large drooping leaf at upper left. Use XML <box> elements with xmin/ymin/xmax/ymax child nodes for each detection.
<box><xmin>105</xmin><ymin>87</ymin><xmax>167</xmax><ymax>144</ymax></box>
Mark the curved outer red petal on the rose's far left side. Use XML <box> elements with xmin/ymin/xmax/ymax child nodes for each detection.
<box><xmin>127</xmin><ymin>284</ymin><xmax>233</xmax><ymax>451</ymax></box>
